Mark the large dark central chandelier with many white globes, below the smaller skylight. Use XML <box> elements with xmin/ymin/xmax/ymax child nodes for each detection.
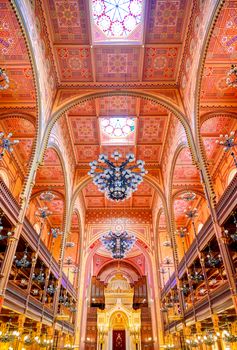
<box><xmin>88</xmin><ymin>151</ymin><xmax>147</xmax><ymax>201</ymax></box>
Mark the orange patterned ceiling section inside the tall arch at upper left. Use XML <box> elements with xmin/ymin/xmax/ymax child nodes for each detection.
<box><xmin>0</xmin><ymin>0</ymin><xmax>35</xmax><ymax>107</ymax></box>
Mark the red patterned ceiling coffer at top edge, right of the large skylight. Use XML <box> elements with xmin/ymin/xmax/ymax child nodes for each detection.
<box><xmin>146</xmin><ymin>0</ymin><xmax>191</xmax><ymax>44</ymax></box>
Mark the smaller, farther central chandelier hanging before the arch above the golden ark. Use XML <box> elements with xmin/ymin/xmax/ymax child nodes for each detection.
<box><xmin>101</xmin><ymin>231</ymin><xmax>136</xmax><ymax>259</ymax></box>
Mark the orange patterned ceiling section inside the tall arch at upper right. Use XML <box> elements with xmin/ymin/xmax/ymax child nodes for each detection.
<box><xmin>201</xmin><ymin>1</ymin><xmax>237</xmax><ymax>106</ymax></box>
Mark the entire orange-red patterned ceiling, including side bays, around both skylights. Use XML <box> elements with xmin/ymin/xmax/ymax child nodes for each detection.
<box><xmin>0</xmin><ymin>0</ymin><xmax>237</xmax><ymax>237</ymax></box>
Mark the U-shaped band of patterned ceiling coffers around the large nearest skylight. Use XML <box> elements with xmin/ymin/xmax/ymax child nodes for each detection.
<box><xmin>44</xmin><ymin>0</ymin><xmax>191</xmax><ymax>84</ymax></box>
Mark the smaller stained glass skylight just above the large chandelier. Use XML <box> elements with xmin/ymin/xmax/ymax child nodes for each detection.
<box><xmin>101</xmin><ymin>117</ymin><xmax>135</xmax><ymax>137</ymax></box>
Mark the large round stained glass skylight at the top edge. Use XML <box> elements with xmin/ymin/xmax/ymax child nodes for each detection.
<box><xmin>92</xmin><ymin>0</ymin><xmax>144</xmax><ymax>39</ymax></box>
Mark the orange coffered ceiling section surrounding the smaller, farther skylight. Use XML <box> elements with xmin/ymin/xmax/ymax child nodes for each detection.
<box><xmin>67</xmin><ymin>96</ymin><xmax>169</xmax><ymax>173</ymax></box>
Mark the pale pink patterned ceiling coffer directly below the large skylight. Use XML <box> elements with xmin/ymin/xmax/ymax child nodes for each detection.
<box><xmin>94</xmin><ymin>46</ymin><xmax>140</xmax><ymax>82</ymax></box>
